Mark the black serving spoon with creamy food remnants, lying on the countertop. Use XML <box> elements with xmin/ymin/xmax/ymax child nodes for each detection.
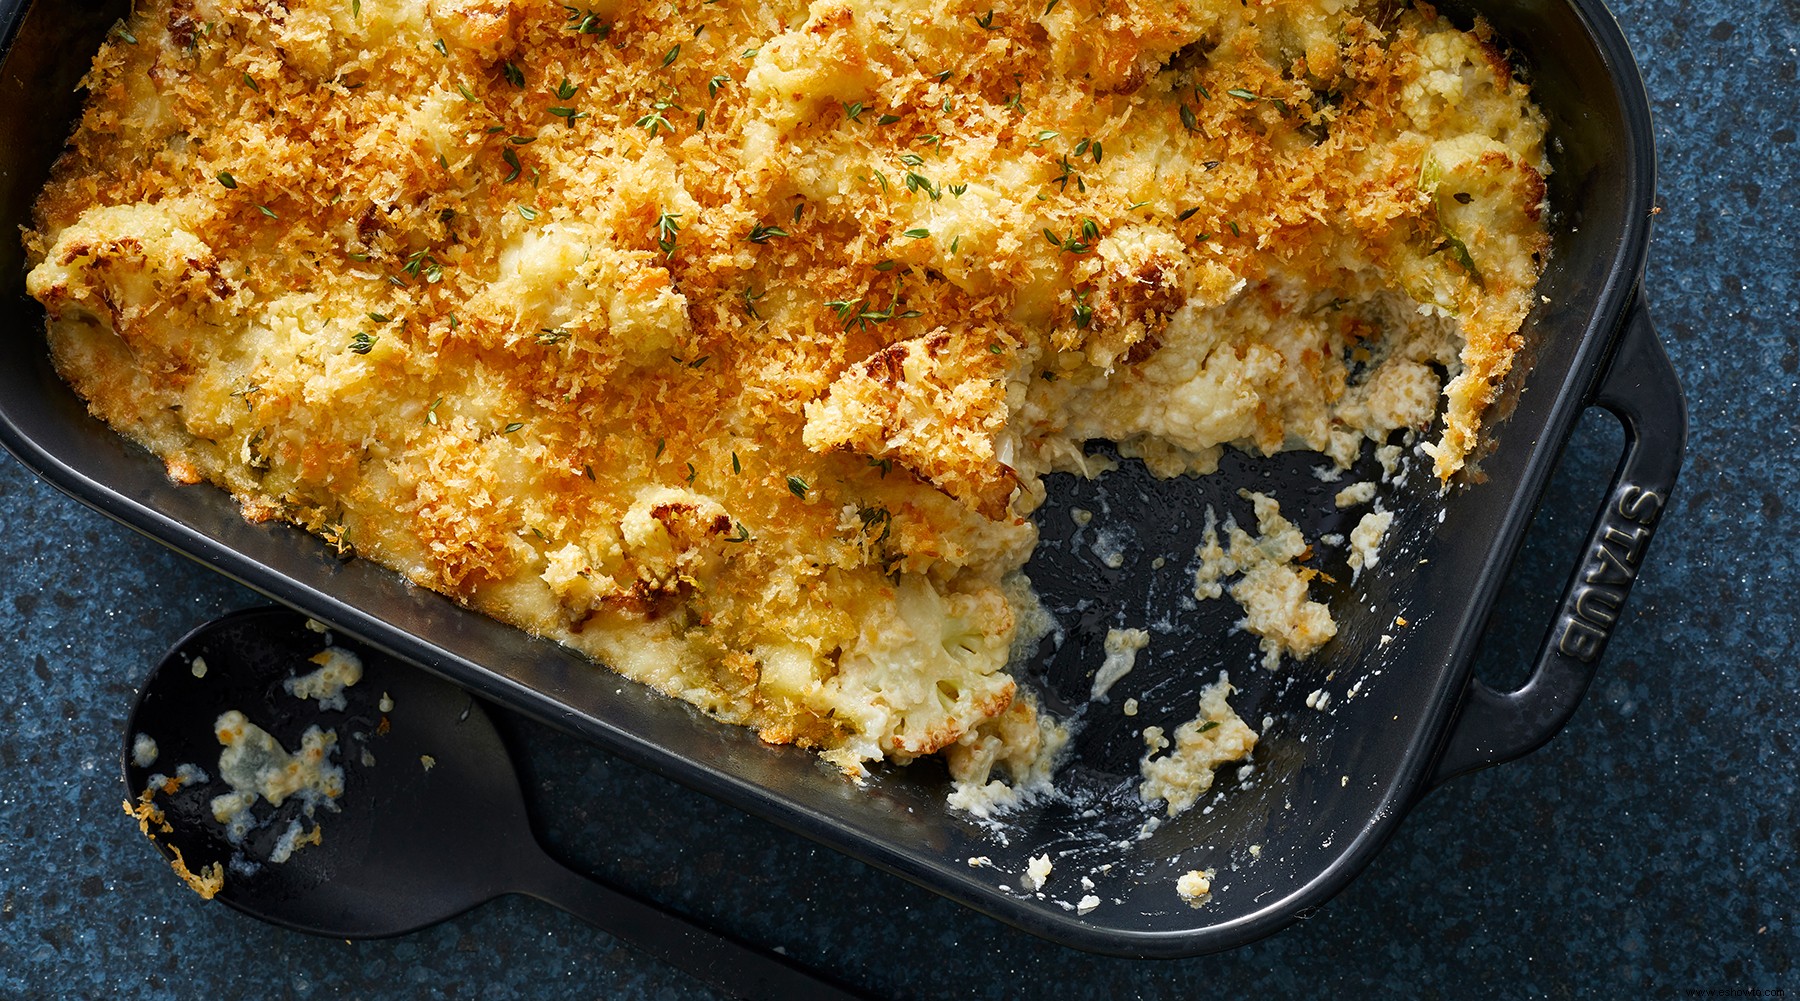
<box><xmin>124</xmin><ymin>609</ymin><xmax>853</xmax><ymax>999</ymax></box>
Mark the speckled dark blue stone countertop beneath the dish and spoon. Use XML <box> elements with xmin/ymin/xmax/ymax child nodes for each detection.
<box><xmin>0</xmin><ymin>0</ymin><xmax>1800</xmax><ymax>1001</ymax></box>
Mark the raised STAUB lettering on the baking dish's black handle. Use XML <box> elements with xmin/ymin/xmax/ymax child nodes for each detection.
<box><xmin>1557</xmin><ymin>484</ymin><xmax>1663</xmax><ymax>663</ymax></box>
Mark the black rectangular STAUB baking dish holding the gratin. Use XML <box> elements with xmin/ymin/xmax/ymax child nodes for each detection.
<box><xmin>0</xmin><ymin>0</ymin><xmax>1687</xmax><ymax>956</ymax></box>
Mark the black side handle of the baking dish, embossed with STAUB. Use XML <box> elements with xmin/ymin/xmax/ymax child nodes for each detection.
<box><xmin>1429</xmin><ymin>293</ymin><xmax>1687</xmax><ymax>785</ymax></box>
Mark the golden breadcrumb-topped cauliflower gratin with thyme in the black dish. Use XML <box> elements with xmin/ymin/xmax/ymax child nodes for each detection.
<box><xmin>25</xmin><ymin>0</ymin><xmax>1548</xmax><ymax>790</ymax></box>
